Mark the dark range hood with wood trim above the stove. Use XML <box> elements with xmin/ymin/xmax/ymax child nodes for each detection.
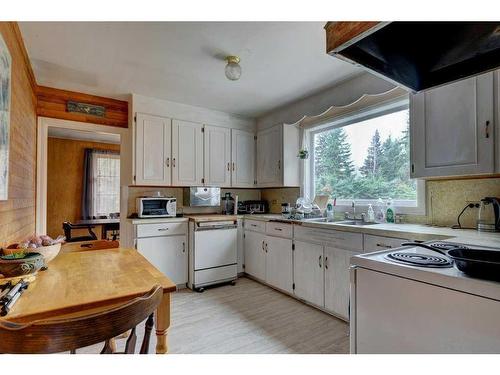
<box><xmin>325</xmin><ymin>22</ymin><xmax>500</xmax><ymax>91</ymax></box>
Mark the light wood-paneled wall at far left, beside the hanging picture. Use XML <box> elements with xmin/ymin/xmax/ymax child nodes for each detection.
<box><xmin>0</xmin><ymin>22</ymin><xmax>36</xmax><ymax>247</ymax></box>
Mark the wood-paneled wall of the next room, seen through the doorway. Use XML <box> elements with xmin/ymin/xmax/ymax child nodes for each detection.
<box><xmin>47</xmin><ymin>138</ymin><xmax>120</xmax><ymax>237</ymax></box>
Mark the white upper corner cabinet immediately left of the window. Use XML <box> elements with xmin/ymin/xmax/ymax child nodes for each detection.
<box><xmin>257</xmin><ymin>124</ymin><xmax>300</xmax><ymax>187</ymax></box>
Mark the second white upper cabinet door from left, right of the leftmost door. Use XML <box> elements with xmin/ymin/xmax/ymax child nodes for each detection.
<box><xmin>172</xmin><ymin>120</ymin><xmax>203</xmax><ymax>186</ymax></box>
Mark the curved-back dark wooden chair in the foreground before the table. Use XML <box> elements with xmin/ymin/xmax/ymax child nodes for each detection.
<box><xmin>0</xmin><ymin>285</ymin><xmax>163</xmax><ymax>354</ymax></box>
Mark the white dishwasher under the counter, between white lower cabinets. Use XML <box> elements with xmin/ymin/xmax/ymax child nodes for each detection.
<box><xmin>188</xmin><ymin>220</ymin><xmax>238</xmax><ymax>291</ymax></box>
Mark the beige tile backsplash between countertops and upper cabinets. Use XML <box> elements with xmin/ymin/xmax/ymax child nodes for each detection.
<box><xmin>128</xmin><ymin>177</ymin><xmax>500</xmax><ymax>227</ymax></box>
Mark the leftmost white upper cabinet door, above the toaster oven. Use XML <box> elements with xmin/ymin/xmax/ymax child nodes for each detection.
<box><xmin>135</xmin><ymin>113</ymin><xmax>172</xmax><ymax>185</ymax></box>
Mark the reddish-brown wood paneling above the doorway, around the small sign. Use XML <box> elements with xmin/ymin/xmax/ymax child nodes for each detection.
<box><xmin>36</xmin><ymin>86</ymin><xmax>128</xmax><ymax>128</ymax></box>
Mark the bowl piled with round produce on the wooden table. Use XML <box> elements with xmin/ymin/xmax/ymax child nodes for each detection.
<box><xmin>0</xmin><ymin>235</ymin><xmax>65</xmax><ymax>277</ymax></box>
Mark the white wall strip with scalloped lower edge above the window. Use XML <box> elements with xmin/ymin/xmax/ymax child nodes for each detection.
<box><xmin>257</xmin><ymin>73</ymin><xmax>394</xmax><ymax>130</ymax></box>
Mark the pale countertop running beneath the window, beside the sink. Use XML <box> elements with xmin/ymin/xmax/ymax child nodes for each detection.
<box><xmin>244</xmin><ymin>214</ymin><xmax>500</xmax><ymax>247</ymax></box>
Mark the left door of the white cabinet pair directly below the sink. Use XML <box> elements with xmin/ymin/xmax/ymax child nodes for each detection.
<box><xmin>293</xmin><ymin>241</ymin><xmax>324</xmax><ymax>307</ymax></box>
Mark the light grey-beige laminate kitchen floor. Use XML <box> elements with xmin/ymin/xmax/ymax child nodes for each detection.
<box><xmin>77</xmin><ymin>277</ymin><xmax>349</xmax><ymax>354</ymax></box>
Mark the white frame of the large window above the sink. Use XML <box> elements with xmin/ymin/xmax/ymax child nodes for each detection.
<box><xmin>304</xmin><ymin>98</ymin><xmax>426</xmax><ymax>215</ymax></box>
